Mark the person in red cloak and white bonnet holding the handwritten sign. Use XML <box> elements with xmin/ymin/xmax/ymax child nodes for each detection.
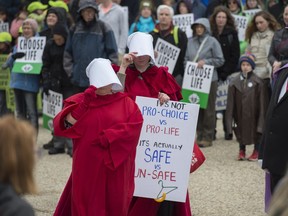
<box><xmin>113</xmin><ymin>32</ymin><xmax>191</xmax><ymax>216</ymax></box>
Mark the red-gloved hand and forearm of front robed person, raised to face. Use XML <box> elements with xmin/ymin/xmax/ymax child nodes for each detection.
<box><xmin>71</xmin><ymin>85</ymin><xmax>97</xmax><ymax>120</ymax></box>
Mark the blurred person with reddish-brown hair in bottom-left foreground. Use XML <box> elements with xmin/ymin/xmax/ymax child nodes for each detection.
<box><xmin>0</xmin><ymin>115</ymin><xmax>37</xmax><ymax>216</ymax></box>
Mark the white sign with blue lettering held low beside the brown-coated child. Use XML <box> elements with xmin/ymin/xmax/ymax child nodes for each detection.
<box><xmin>215</xmin><ymin>79</ymin><xmax>229</xmax><ymax>111</ymax></box>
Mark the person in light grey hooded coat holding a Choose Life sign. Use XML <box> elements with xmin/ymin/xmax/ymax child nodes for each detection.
<box><xmin>185</xmin><ymin>18</ymin><xmax>224</xmax><ymax>147</ymax></box>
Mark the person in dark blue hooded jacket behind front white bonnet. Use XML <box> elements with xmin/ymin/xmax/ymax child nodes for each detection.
<box><xmin>63</xmin><ymin>0</ymin><xmax>118</xmax><ymax>93</ymax></box>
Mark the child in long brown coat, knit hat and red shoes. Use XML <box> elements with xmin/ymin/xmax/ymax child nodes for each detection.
<box><xmin>226</xmin><ymin>53</ymin><xmax>267</xmax><ymax>161</ymax></box>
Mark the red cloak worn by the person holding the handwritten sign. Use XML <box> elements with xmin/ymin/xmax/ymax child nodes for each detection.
<box><xmin>113</xmin><ymin>65</ymin><xmax>196</xmax><ymax>216</ymax></box>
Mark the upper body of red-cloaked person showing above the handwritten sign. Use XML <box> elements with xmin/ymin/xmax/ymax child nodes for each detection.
<box><xmin>113</xmin><ymin>32</ymin><xmax>182</xmax><ymax>103</ymax></box>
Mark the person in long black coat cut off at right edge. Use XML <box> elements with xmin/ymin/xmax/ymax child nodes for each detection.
<box><xmin>259</xmin><ymin>64</ymin><xmax>288</xmax><ymax>193</ymax></box>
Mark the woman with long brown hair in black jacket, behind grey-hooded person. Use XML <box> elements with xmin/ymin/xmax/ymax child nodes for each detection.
<box><xmin>210</xmin><ymin>6</ymin><xmax>240</xmax><ymax>140</ymax></box>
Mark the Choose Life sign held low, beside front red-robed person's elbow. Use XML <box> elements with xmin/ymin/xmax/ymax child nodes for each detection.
<box><xmin>43</xmin><ymin>90</ymin><xmax>63</xmax><ymax>131</ymax></box>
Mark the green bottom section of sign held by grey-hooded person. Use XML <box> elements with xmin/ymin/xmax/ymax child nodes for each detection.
<box><xmin>182</xmin><ymin>89</ymin><xmax>209</xmax><ymax>109</ymax></box>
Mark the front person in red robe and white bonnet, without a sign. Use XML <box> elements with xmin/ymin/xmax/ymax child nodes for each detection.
<box><xmin>54</xmin><ymin>58</ymin><xmax>143</xmax><ymax>216</ymax></box>
